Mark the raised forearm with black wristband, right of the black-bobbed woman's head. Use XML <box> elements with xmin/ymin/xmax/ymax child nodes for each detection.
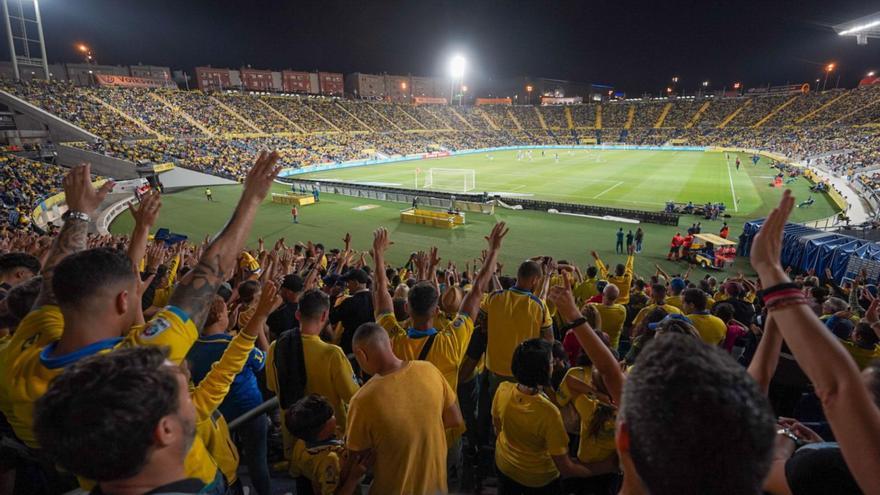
<box><xmin>549</xmin><ymin>276</ymin><xmax>625</xmax><ymax>405</ymax></box>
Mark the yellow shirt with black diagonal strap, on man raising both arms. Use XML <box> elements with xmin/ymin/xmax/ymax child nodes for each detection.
<box><xmin>376</xmin><ymin>313</ymin><xmax>474</xmax><ymax>390</ymax></box>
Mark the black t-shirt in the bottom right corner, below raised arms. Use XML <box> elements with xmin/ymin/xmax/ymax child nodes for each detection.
<box><xmin>785</xmin><ymin>444</ymin><xmax>862</xmax><ymax>495</ymax></box>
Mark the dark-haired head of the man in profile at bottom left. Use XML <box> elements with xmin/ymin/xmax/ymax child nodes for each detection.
<box><xmin>35</xmin><ymin>347</ymin><xmax>208</xmax><ymax>493</ymax></box>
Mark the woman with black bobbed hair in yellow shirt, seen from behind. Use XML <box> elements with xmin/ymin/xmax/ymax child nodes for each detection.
<box><xmin>492</xmin><ymin>339</ymin><xmax>595</xmax><ymax>495</ymax></box>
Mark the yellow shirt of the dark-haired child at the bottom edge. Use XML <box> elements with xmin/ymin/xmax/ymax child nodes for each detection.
<box><xmin>290</xmin><ymin>440</ymin><xmax>345</xmax><ymax>495</ymax></box>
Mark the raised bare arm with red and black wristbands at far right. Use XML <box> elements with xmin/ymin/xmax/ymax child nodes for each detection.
<box><xmin>751</xmin><ymin>191</ymin><xmax>880</xmax><ymax>493</ymax></box>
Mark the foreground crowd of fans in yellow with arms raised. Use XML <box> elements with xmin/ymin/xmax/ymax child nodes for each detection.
<box><xmin>0</xmin><ymin>153</ymin><xmax>880</xmax><ymax>495</ymax></box>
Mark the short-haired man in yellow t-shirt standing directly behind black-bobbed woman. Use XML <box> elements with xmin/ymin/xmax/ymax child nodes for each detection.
<box><xmin>480</xmin><ymin>261</ymin><xmax>553</xmax><ymax>388</ymax></box>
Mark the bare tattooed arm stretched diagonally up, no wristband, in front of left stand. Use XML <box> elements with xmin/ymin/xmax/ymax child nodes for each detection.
<box><xmin>169</xmin><ymin>151</ymin><xmax>281</xmax><ymax>329</ymax></box>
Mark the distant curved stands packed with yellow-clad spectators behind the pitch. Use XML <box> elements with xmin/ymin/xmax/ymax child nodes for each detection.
<box><xmin>4</xmin><ymin>81</ymin><xmax>880</xmax><ymax>188</ymax></box>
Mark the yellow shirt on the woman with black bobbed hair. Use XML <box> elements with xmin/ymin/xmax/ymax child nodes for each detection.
<box><xmin>492</xmin><ymin>382</ymin><xmax>568</xmax><ymax>488</ymax></box>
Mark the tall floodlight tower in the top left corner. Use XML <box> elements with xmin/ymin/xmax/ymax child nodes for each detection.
<box><xmin>2</xmin><ymin>0</ymin><xmax>51</xmax><ymax>81</ymax></box>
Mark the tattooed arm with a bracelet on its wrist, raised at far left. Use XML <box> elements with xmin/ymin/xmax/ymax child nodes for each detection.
<box><xmin>34</xmin><ymin>164</ymin><xmax>113</xmax><ymax>308</ymax></box>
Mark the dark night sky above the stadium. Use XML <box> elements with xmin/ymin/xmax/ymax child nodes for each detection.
<box><xmin>41</xmin><ymin>0</ymin><xmax>880</xmax><ymax>95</ymax></box>
